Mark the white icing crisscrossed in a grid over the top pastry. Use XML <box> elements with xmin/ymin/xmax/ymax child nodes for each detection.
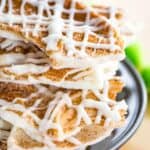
<box><xmin>0</xmin><ymin>0</ymin><xmax>120</xmax><ymax>58</ymax></box>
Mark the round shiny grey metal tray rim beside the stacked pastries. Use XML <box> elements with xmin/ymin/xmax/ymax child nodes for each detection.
<box><xmin>88</xmin><ymin>61</ymin><xmax>147</xmax><ymax>150</ymax></box>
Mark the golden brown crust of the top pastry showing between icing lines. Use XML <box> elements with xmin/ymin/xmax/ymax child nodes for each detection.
<box><xmin>0</xmin><ymin>0</ymin><xmax>124</xmax><ymax>67</ymax></box>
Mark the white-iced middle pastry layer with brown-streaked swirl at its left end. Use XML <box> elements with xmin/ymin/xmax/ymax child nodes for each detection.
<box><xmin>0</xmin><ymin>39</ymin><xmax>118</xmax><ymax>89</ymax></box>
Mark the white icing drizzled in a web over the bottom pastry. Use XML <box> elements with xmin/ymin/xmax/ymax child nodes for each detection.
<box><xmin>0</xmin><ymin>81</ymin><xmax>127</xmax><ymax>146</ymax></box>
